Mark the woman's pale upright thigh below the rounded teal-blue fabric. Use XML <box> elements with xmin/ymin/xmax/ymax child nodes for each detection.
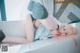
<box><xmin>25</xmin><ymin>14</ymin><xmax>34</xmax><ymax>42</ymax></box>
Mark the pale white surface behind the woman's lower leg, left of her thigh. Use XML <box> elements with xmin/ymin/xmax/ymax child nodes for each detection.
<box><xmin>0</xmin><ymin>20</ymin><xmax>25</xmax><ymax>37</ymax></box>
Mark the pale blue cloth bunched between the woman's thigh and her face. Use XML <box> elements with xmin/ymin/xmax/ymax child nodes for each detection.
<box><xmin>35</xmin><ymin>24</ymin><xmax>51</xmax><ymax>40</ymax></box>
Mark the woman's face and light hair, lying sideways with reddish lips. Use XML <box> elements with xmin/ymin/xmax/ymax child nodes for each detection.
<box><xmin>52</xmin><ymin>25</ymin><xmax>76</xmax><ymax>36</ymax></box>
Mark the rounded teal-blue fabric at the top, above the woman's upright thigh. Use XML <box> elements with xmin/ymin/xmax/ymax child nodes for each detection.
<box><xmin>28</xmin><ymin>0</ymin><xmax>48</xmax><ymax>19</ymax></box>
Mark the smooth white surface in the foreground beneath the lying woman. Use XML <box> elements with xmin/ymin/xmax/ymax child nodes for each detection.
<box><xmin>1</xmin><ymin>37</ymin><xmax>80</xmax><ymax>53</ymax></box>
